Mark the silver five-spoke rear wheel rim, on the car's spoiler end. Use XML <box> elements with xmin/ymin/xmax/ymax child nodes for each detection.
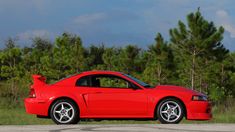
<box><xmin>53</xmin><ymin>102</ymin><xmax>74</xmax><ymax>123</ymax></box>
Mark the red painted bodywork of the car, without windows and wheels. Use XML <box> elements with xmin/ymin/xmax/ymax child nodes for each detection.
<box><xmin>25</xmin><ymin>71</ymin><xmax>212</xmax><ymax>120</ymax></box>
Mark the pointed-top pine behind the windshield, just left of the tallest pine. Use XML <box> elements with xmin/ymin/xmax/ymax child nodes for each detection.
<box><xmin>144</xmin><ymin>33</ymin><xmax>173</xmax><ymax>85</ymax></box>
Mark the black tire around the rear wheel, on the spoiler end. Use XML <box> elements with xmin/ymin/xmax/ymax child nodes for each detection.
<box><xmin>50</xmin><ymin>99</ymin><xmax>79</xmax><ymax>124</ymax></box>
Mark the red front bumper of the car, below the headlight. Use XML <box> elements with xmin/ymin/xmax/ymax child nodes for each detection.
<box><xmin>187</xmin><ymin>101</ymin><xmax>212</xmax><ymax>120</ymax></box>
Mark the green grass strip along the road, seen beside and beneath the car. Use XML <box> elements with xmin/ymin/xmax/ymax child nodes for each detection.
<box><xmin>0</xmin><ymin>105</ymin><xmax>235</xmax><ymax>125</ymax></box>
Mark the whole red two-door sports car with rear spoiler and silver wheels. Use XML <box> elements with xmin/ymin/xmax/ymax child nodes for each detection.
<box><xmin>24</xmin><ymin>71</ymin><xmax>212</xmax><ymax>124</ymax></box>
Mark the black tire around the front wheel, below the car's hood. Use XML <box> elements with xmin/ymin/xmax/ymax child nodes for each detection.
<box><xmin>156</xmin><ymin>98</ymin><xmax>185</xmax><ymax>124</ymax></box>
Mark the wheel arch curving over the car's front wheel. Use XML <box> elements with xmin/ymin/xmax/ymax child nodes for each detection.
<box><xmin>153</xmin><ymin>96</ymin><xmax>187</xmax><ymax>119</ymax></box>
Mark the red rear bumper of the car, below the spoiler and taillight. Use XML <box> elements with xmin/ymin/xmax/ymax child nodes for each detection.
<box><xmin>24</xmin><ymin>98</ymin><xmax>49</xmax><ymax>116</ymax></box>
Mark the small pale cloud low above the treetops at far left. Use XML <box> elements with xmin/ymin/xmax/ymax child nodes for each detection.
<box><xmin>17</xmin><ymin>30</ymin><xmax>52</xmax><ymax>40</ymax></box>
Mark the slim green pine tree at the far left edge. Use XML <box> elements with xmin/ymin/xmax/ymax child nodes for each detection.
<box><xmin>0</xmin><ymin>38</ymin><xmax>23</xmax><ymax>103</ymax></box>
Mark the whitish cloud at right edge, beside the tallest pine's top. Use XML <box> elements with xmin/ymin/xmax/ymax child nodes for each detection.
<box><xmin>216</xmin><ymin>10</ymin><xmax>235</xmax><ymax>38</ymax></box>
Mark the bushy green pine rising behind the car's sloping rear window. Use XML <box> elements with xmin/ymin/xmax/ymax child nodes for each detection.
<box><xmin>53</xmin><ymin>33</ymin><xmax>84</xmax><ymax>79</ymax></box>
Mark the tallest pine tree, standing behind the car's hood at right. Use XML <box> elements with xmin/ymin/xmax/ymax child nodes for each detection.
<box><xmin>170</xmin><ymin>9</ymin><xmax>227</xmax><ymax>89</ymax></box>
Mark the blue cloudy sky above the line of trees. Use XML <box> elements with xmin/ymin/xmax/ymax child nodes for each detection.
<box><xmin>0</xmin><ymin>0</ymin><xmax>235</xmax><ymax>51</ymax></box>
